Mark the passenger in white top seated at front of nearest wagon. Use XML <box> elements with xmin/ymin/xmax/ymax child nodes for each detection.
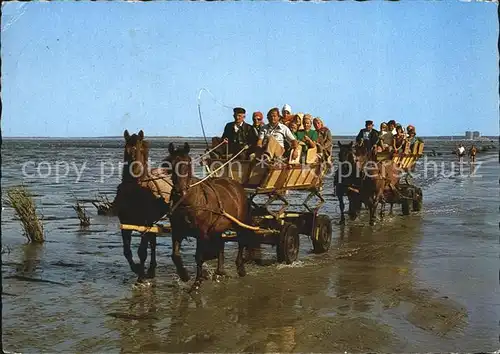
<box><xmin>257</xmin><ymin>108</ymin><xmax>298</xmax><ymax>159</ymax></box>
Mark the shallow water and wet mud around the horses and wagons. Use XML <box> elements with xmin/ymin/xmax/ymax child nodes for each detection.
<box><xmin>2</xmin><ymin>140</ymin><xmax>500</xmax><ymax>352</ymax></box>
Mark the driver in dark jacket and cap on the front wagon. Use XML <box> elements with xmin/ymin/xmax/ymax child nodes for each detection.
<box><xmin>222</xmin><ymin>107</ymin><xmax>257</xmax><ymax>159</ymax></box>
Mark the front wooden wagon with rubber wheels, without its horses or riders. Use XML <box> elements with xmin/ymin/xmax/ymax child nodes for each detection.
<box><xmin>207</xmin><ymin>153</ymin><xmax>332</xmax><ymax>263</ymax></box>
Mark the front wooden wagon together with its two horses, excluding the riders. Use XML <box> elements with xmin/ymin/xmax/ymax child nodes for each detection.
<box><xmin>115</xmin><ymin>131</ymin><xmax>332</xmax><ymax>288</ymax></box>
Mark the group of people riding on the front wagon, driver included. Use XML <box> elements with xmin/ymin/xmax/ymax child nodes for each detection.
<box><xmin>212</xmin><ymin>104</ymin><xmax>333</xmax><ymax>163</ymax></box>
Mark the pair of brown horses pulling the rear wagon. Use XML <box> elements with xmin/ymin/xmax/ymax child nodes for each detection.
<box><xmin>345</xmin><ymin>145</ymin><xmax>400</xmax><ymax>225</ymax></box>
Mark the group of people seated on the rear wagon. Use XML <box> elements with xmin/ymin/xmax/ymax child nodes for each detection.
<box><xmin>356</xmin><ymin>120</ymin><xmax>422</xmax><ymax>158</ymax></box>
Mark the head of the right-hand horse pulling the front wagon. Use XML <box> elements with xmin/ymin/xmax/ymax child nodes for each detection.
<box><xmin>165</xmin><ymin>143</ymin><xmax>193</xmax><ymax>196</ymax></box>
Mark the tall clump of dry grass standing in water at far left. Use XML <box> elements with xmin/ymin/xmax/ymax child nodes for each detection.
<box><xmin>7</xmin><ymin>186</ymin><xmax>45</xmax><ymax>243</ymax></box>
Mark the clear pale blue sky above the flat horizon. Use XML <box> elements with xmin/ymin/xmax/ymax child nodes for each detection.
<box><xmin>1</xmin><ymin>0</ymin><xmax>499</xmax><ymax>137</ymax></box>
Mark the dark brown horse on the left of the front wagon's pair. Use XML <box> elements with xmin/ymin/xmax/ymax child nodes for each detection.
<box><xmin>113</xmin><ymin>130</ymin><xmax>172</xmax><ymax>283</ymax></box>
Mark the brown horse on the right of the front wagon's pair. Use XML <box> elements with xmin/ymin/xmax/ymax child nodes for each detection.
<box><xmin>167</xmin><ymin>143</ymin><xmax>251</xmax><ymax>290</ymax></box>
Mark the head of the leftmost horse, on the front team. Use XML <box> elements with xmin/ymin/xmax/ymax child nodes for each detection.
<box><xmin>123</xmin><ymin>130</ymin><xmax>149</xmax><ymax>178</ymax></box>
